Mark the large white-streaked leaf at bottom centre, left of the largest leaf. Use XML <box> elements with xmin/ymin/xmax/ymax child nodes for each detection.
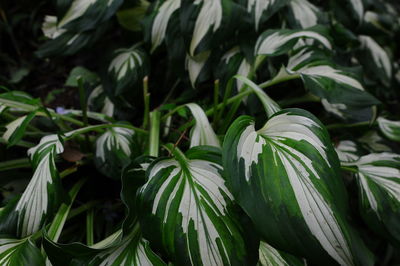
<box><xmin>138</xmin><ymin>146</ymin><xmax>257</xmax><ymax>265</ymax></box>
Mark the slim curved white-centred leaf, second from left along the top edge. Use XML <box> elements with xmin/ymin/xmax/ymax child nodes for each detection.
<box><xmin>151</xmin><ymin>0</ymin><xmax>181</xmax><ymax>52</ymax></box>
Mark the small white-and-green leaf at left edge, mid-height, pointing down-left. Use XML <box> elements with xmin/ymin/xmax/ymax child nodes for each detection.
<box><xmin>3</xmin><ymin>112</ymin><xmax>36</xmax><ymax>147</ymax></box>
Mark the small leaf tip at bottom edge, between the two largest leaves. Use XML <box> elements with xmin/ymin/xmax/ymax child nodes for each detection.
<box><xmin>258</xmin><ymin>241</ymin><xmax>307</xmax><ymax>266</ymax></box>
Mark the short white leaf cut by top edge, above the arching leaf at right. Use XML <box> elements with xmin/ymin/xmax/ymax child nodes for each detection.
<box><xmin>289</xmin><ymin>0</ymin><xmax>321</xmax><ymax>29</ymax></box>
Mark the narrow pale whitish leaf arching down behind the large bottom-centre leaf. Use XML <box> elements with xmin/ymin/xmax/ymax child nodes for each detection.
<box><xmin>186</xmin><ymin>103</ymin><xmax>221</xmax><ymax>148</ymax></box>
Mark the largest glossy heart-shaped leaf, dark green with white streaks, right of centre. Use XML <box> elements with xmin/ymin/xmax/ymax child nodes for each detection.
<box><xmin>223</xmin><ymin>109</ymin><xmax>373</xmax><ymax>265</ymax></box>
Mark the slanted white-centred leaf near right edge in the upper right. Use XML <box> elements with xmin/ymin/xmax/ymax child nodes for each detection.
<box><xmin>358</xmin><ymin>35</ymin><xmax>392</xmax><ymax>83</ymax></box>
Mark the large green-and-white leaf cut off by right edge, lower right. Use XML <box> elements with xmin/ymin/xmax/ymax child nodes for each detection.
<box><xmin>343</xmin><ymin>152</ymin><xmax>400</xmax><ymax>246</ymax></box>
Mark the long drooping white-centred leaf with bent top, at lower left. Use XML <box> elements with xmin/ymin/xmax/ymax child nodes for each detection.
<box><xmin>15</xmin><ymin>135</ymin><xmax>64</xmax><ymax>237</ymax></box>
